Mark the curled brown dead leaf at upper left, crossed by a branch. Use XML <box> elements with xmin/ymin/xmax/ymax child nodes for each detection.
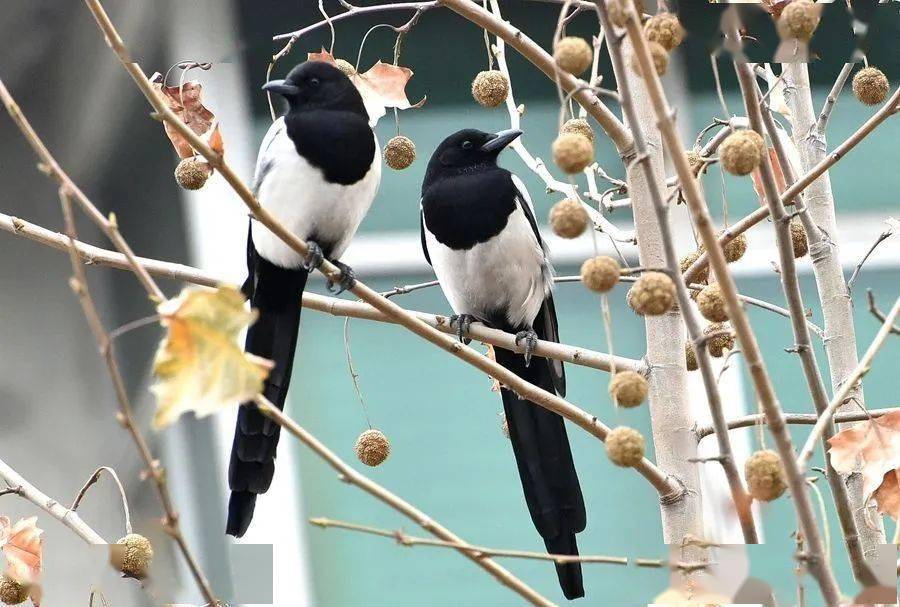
<box><xmin>150</xmin><ymin>72</ymin><xmax>225</xmax><ymax>158</ymax></box>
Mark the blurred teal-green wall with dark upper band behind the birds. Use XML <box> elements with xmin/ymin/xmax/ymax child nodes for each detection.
<box><xmin>234</xmin><ymin>1</ymin><xmax>900</xmax><ymax>607</ymax></box>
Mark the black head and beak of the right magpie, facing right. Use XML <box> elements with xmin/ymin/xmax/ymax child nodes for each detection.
<box><xmin>425</xmin><ymin>129</ymin><xmax>522</xmax><ymax>181</ymax></box>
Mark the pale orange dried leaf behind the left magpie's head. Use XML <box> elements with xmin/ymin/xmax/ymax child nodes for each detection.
<box><xmin>307</xmin><ymin>49</ymin><xmax>426</xmax><ymax>126</ymax></box>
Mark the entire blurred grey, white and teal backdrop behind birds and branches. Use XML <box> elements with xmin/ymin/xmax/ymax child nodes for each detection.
<box><xmin>0</xmin><ymin>0</ymin><xmax>900</xmax><ymax>607</ymax></box>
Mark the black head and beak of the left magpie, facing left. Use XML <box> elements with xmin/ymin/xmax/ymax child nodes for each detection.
<box><xmin>263</xmin><ymin>61</ymin><xmax>369</xmax><ymax>121</ymax></box>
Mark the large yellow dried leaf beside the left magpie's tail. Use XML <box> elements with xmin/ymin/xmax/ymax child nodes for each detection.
<box><xmin>151</xmin><ymin>286</ymin><xmax>272</xmax><ymax>428</ymax></box>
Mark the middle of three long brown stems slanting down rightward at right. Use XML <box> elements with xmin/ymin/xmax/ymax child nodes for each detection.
<box><xmin>626</xmin><ymin>0</ymin><xmax>840</xmax><ymax>605</ymax></box>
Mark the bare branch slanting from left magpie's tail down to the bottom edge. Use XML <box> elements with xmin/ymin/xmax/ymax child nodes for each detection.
<box><xmin>255</xmin><ymin>395</ymin><xmax>553</xmax><ymax>607</ymax></box>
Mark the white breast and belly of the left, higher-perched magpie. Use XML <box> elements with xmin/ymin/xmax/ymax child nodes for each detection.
<box><xmin>251</xmin><ymin>122</ymin><xmax>381</xmax><ymax>268</ymax></box>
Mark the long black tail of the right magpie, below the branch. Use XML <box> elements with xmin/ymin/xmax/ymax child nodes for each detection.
<box><xmin>495</xmin><ymin>344</ymin><xmax>586</xmax><ymax>599</ymax></box>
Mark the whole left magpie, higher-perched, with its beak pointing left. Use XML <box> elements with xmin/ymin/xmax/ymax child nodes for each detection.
<box><xmin>226</xmin><ymin>61</ymin><xmax>381</xmax><ymax>537</ymax></box>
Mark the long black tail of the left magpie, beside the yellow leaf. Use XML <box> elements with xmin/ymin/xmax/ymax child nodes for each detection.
<box><xmin>226</xmin><ymin>251</ymin><xmax>309</xmax><ymax>537</ymax></box>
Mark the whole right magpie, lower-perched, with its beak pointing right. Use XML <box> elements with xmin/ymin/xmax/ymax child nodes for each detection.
<box><xmin>420</xmin><ymin>129</ymin><xmax>586</xmax><ymax>599</ymax></box>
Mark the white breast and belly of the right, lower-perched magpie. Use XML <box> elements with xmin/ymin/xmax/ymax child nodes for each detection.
<box><xmin>425</xmin><ymin>206</ymin><xmax>549</xmax><ymax>326</ymax></box>
